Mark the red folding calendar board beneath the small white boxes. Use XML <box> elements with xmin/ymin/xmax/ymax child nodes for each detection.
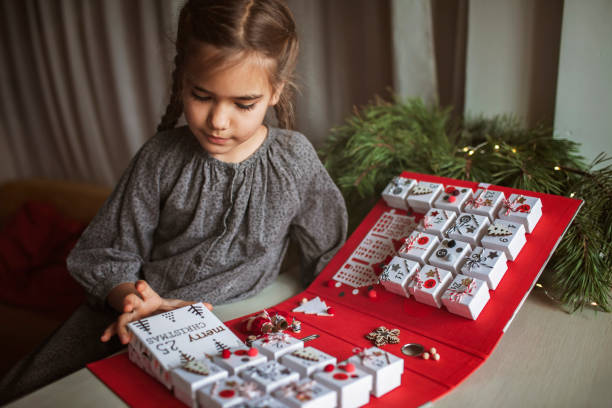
<box><xmin>88</xmin><ymin>172</ymin><xmax>581</xmax><ymax>407</ymax></box>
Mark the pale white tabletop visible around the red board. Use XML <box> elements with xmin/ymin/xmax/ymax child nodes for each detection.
<box><xmin>8</xmin><ymin>268</ymin><xmax>612</xmax><ymax>408</ymax></box>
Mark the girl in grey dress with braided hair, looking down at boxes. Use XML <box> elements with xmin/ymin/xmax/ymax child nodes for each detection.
<box><xmin>0</xmin><ymin>0</ymin><xmax>347</xmax><ymax>401</ymax></box>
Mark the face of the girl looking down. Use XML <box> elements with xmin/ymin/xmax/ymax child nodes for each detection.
<box><xmin>182</xmin><ymin>44</ymin><xmax>282</xmax><ymax>163</ymax></box>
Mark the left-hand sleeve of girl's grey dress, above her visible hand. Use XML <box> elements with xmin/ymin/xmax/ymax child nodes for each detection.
<box><xmin>67</xmin><ymin>139</ymin><xmax>160</xmax><ymax>305</ymax></box>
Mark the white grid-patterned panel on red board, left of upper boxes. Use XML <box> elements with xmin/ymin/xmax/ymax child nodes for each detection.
<box><xmin>333</xmin><ymin>210</ymin><xmax>416</xmax><ymax>288</ymax></box>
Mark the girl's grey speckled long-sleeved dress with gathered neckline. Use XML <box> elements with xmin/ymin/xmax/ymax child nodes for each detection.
<box><xmin>0</xmin><ymin>127</ymin><xmax>347</xmax><ymax>401</ymax></box>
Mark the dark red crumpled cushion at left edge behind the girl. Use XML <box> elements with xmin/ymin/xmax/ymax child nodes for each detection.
<box><xmin>0</xmin><ymin>201</ymin><xmax>85</xmax><ymax>317</ymax></box>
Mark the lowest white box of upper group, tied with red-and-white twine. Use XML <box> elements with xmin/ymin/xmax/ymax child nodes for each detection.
<box><xmin>442</xmin><ymin>274</ymin><xmax>489</xmax><ymax>320</ymax></box>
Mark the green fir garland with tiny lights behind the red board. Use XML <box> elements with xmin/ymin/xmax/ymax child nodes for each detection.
<box><xmin>319</xmin><ymin>98</ymin><xmax>612</xmax><ymax>312</ymax></box>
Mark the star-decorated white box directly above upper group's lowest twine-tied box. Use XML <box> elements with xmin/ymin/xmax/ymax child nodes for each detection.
<box><xmin>461</xmin><ymin>247</ymin><xmax>508</xmax><ymax>290</ymax></box>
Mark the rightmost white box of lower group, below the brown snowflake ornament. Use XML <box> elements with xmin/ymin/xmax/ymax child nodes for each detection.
<box><xmin>347</xmin><ymin>347</ymin><xmax>404</xmax><ymax>397</ymax></box>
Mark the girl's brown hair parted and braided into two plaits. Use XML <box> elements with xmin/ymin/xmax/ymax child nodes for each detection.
<box><xmin>157</xmin><ymin>0</ymin><xmax>299</xmax><ymax>132</ymax></box>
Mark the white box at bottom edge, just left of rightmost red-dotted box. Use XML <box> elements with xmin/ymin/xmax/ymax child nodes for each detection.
<box><xmin>274</xmin><ymin>378</ymin><xmax>338</xmax><ymax>408</ymax></box>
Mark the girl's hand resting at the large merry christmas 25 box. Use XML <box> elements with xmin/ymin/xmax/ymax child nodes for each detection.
<box><xmin>100</xmin><ymin>280</ymin><xmax>212</xmax><ymax>344</ymax></box>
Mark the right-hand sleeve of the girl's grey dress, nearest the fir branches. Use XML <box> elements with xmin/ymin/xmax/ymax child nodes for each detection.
<box><xmin>291</xmin><ymin>139</ymin><xmax>348</xmax><ymax>283</ymax></box>
